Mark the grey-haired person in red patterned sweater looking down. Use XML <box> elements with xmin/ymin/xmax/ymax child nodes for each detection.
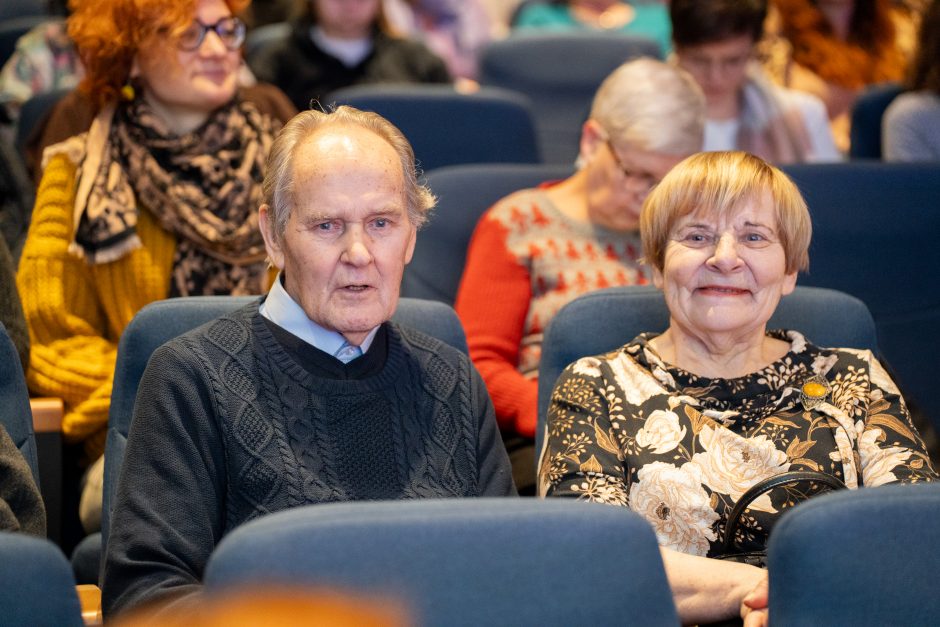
<box><xmin>456</xmin><ymin>59</ymin><xmax>705</xmax><ymax>493</ymax></box>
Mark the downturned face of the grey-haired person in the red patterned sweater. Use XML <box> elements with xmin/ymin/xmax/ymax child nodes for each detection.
<box><xmin>586</xmin><ymin>127</ymin><xmax>685</xmax><ymax>231</ymax></box>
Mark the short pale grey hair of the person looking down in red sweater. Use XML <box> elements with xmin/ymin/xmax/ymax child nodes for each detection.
<box><xmin>591</xmin><ymin>58</ymin><xmax>705</xmax><ymax>155</ymax></box>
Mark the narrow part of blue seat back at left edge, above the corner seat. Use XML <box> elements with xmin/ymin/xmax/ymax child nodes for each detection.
<box><xmin>0</xmin><ymin>323</ymin><xmax>39</xmax><ymax>486</ymax></box>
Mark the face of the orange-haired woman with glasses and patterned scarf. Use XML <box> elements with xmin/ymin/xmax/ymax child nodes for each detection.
<box><xmin>134</xmin><ymin>0</ymin><xmax>241</xmax><ymax>134</ymax></box>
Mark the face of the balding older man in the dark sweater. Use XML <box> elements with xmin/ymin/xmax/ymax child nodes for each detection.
<box><xmin>261</xmin><ymin>126</ymin><xmax>417</xmax><ymax>345</ymax></box>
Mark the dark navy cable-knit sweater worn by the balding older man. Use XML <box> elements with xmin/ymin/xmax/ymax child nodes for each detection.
<box><xmin>102</xmin><ymin>303</ymin><xmax>515</xmax><ymax>614</ymax></box>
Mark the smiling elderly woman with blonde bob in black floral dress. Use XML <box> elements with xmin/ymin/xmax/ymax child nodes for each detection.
<box><xmin>539</xmin><ymin>152</ymin><xmax>937</xmax><ymax>622</ymax></box>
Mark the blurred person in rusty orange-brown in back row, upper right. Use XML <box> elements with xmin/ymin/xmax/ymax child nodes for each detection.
<box><xmin>761</xmin><ymin>0</ymin><xmax>915</xmax><ymax>153</ymax></box>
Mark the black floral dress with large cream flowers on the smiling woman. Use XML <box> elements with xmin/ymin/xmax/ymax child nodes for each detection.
<box><xmin>539</xmin><ymin>331</ymin><xmax>938</xmax><ymax>556</ymax></box>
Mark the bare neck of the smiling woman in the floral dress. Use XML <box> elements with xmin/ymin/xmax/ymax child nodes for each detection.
<box><xmin>650</xmin><ymin>321</ymin><xmax>790</xmax><ymax>379</ymax></box>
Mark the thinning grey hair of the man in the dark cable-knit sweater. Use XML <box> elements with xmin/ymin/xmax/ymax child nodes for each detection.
<box><xmin>262</xmin><ymin>106</ymin><xmax>436</xmax><ymax>237</ymax></box>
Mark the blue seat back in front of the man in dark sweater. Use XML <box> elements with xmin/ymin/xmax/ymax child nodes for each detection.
<box><xmin>205</xmin><ymin>498</ymin><xmax>678</xmax><ymax>627</ymax></box>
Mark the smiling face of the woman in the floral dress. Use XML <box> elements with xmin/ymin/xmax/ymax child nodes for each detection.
<box><xmin>653</xmin><ymin>194</ymin><xmax>796</xmax><ymax>346</ymax></box>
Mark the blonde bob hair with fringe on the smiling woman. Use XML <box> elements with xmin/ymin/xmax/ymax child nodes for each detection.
<box><xmin>640</xmin><ymin>152</ymin><xmax>813</xmax><ymax>274</ymax></box>
